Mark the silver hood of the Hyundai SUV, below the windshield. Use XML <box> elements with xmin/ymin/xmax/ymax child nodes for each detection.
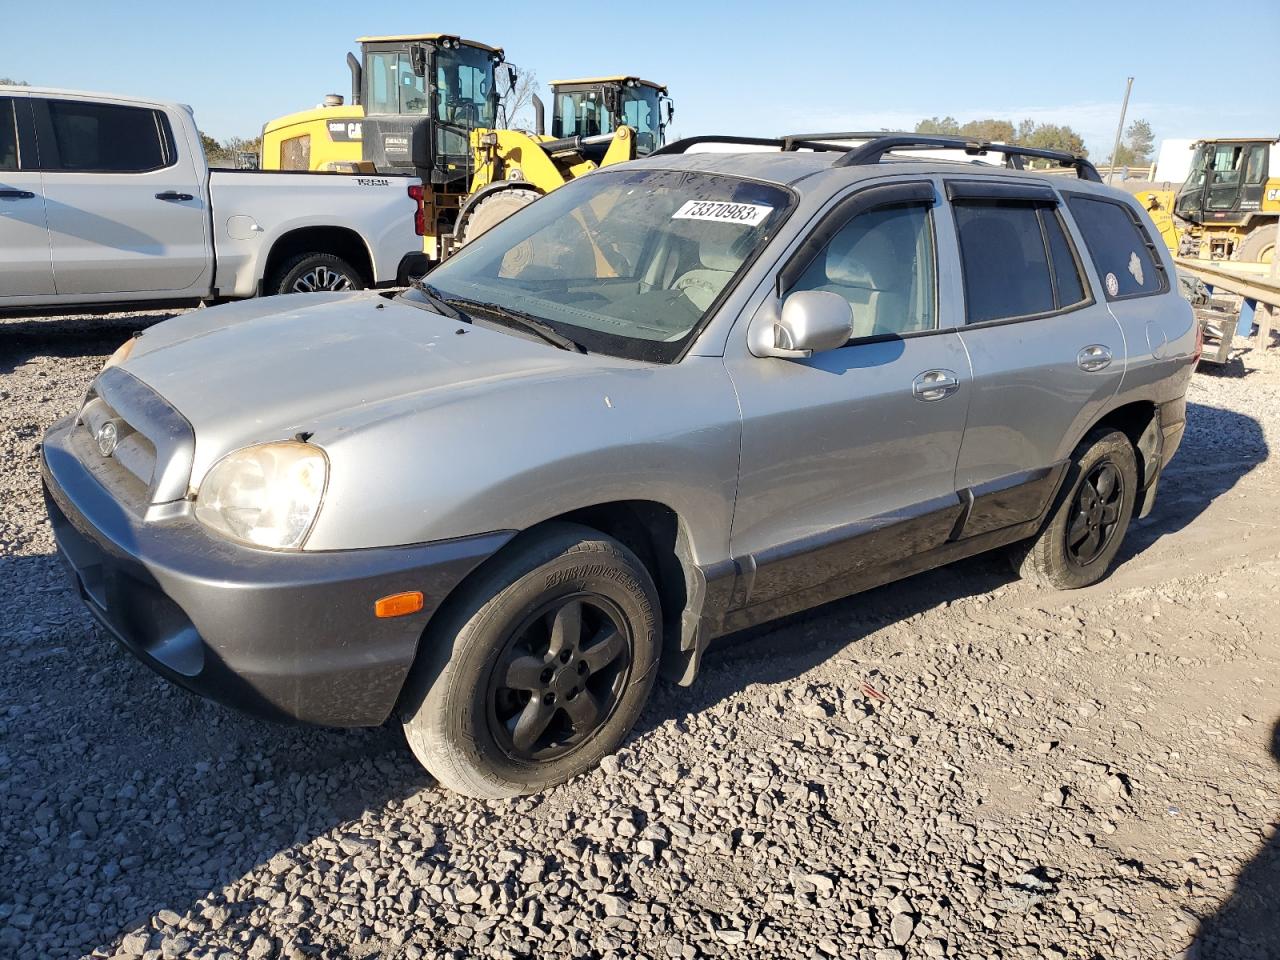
<box><xmin>123</xmin><ymin>292</ymin><xmax>599</xmax><ymax>470</ymax></box>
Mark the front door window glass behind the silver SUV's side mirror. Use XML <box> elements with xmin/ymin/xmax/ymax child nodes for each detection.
<box><xmin>787</xmin><ymin>204</ymin><xmax>937</xmax><ymax>339</ymax></box>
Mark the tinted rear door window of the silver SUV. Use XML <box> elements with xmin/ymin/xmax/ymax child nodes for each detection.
<box><xmin>954</xmin><ymin>200</ymin><xmax>1085</xmax><ymax>324</ymax></box>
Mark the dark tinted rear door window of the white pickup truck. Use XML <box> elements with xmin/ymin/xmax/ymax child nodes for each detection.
<box><xmin>45</xmin><ymin>100</ymin><xmax>173</xmax><ymax>173</ymax></box>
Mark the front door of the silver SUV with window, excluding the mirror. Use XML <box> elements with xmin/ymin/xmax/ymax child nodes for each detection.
<box><xmin>724</xmin><ymin>182</ymin><xmax>970</xmax><ymax>627</ymax></box>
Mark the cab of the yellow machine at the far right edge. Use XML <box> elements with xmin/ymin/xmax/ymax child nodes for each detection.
<box><xmin>1174</xmin><ymin>138</ymin><xmax>1280</xmax><ymax>225</ymax></box>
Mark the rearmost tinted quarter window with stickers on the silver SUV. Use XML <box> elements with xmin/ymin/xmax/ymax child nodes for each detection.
<box><xmin>1066</xmin><ymin>193</ymin><xmax>1169</xmax><ymax>300</ymax></box>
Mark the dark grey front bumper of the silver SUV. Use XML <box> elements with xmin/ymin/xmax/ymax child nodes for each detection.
<box><xmin>41</xmin><ymin>419</ymin><xmax>512</xmax><ymax>727</ymax></box>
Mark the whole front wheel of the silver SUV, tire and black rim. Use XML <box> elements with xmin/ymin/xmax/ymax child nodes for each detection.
<box><xmin>404</xmin><ymin>524</ymin><xmax>662</xmax><ymax>799</ymax></box>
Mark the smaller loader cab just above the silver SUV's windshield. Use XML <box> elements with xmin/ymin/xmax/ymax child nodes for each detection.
<box><xmin>552</xmin><ymin>77</ymin><xmax>675</xmax><ymax>156</ymax></box>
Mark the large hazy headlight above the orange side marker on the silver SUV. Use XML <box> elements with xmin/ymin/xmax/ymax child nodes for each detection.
<box><xmin>196</xmin><ymin>440</ymin><xmax>329</xmax><ymax>550</ymax></box>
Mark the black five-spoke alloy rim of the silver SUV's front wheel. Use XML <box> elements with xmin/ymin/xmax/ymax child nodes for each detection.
<box><xmin>488</xmin><ymin>594</ymin><xmax>632</xmax><ymax>763</ymax></box>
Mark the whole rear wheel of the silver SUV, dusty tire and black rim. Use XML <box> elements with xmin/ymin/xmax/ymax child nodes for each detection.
<box><xmin>1014</xmin><ymin>428</ymin><xmax>1138</xmax><ymax>590</ymax></box>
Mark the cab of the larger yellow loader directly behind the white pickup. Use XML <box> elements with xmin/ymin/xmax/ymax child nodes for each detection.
<box><xmin>349</xmin><ymin>33</ymin><xmax>508</xmax><ymax>186</ymax></box>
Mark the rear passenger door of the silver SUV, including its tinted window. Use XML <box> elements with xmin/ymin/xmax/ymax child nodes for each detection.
<box><xmin>945</xmin><ymin>178</ymin><xmax>1125</xmax><ymax>536</ymax></box>
